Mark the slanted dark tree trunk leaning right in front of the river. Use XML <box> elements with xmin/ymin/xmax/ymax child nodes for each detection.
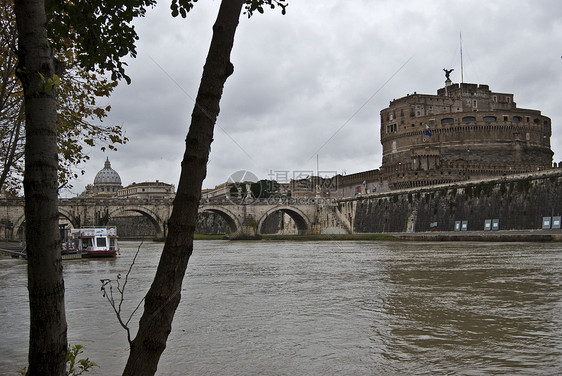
<box><xmin>123</xmin><ymin>0</ymin><xmax>244</xmax><ymax>376</ymax></box>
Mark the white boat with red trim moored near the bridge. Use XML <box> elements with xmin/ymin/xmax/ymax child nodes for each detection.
<box><xmin>70</xmin><ymin>226</ymin><xmax>119</xmax><ymax>258</ymax></box>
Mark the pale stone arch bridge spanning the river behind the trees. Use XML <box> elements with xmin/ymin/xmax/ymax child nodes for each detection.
<box><xmin>0</xmin><ymin>198</ymin><xmax>351</xmax><ymax>240</ymax></box>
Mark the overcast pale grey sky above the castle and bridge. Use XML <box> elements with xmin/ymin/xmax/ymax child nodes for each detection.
<box><xmin>61</xmin><ymin>0</ymin><xmax>562</xmax><ymax>197</ymax></box>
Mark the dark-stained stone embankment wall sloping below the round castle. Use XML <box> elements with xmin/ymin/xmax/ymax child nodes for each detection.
<box><xmin>352</xmin><ymin>169</ymin><xmax>562</xmax><ymax>233</ymax></box>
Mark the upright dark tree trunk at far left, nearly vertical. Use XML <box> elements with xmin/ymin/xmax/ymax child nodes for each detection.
<box><xmin>15</xmin><ymin>0</ymin><xmax>67</xmax><ymax>375</ymax></box>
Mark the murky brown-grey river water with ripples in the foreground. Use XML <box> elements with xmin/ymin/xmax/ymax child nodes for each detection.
<box><xmin>0</xmin><ymin>241</ymin><xmax>562</xmax><ymax>375</ymax></box>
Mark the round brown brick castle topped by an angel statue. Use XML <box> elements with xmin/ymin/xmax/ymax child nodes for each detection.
<box><xmin>374</xmin><ymin>71</ymin><xmax>553</xmax><ymax>189</ymax></box>
